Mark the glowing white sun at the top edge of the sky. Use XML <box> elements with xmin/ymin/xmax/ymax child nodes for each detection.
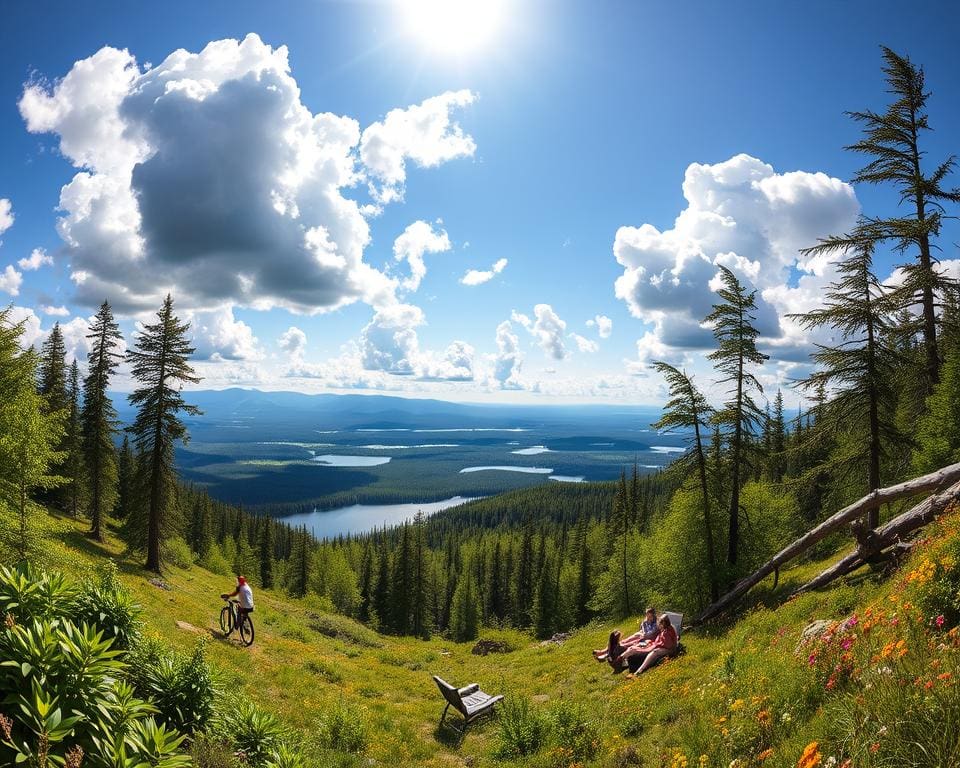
<box><xmin>398</xmin><ymin>0</ymin><xmax>505</xmax><ymax>54</ymax></box>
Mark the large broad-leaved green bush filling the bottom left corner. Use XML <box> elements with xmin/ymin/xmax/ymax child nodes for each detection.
<box><xmin>0</xmin><ymin>566</ymin><xmax>190</xmax><ymax>768</ymax></box>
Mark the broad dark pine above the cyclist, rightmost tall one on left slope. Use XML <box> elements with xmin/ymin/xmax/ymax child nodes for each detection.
<box><xmin>127</xmin><ymin>295</ymin><xmax>200</xmax><ymax>572</ymax></box>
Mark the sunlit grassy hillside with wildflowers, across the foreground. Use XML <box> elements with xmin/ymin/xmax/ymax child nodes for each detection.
<box><xmin>26</xmin><ymin>513</ymin><xmax>960</xmax><ymax>768</ymax></box>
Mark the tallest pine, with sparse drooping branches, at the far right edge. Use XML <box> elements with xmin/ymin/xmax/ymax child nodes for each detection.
<box><xmin>840</xmin><ymin>47</ymin><xmax>960</xmax><ymax>392</ymax></box>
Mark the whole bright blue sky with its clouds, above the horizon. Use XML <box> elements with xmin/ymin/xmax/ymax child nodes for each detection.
<box><xmin>0</xmin><ymin>0</ymin><xmax>960</xmax><ymax>403</ymax></box>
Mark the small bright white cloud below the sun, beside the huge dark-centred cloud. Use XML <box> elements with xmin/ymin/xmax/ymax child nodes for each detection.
<box><xmin>360</xmin><ymin>90</ymin><xmax>477</xmax><ymax>203</ymax></box>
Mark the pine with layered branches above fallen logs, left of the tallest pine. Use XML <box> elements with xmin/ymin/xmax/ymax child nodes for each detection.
<box><xmin>792</xmin><ymin>238</ymin><xmax>900</xmax><ymax>528</ymax></box>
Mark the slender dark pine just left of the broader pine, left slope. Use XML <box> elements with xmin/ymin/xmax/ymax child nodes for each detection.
<box><xmin>80</xmin><ymin>302</ymin><xmax>124</xmax><ymax>540</ymax></box>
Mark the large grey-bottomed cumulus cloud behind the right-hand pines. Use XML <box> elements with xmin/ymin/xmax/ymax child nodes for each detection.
<box><xmin>613</xmin><ymin>154</ymin><xmax>859</xmax><ymax>366</ymax></box>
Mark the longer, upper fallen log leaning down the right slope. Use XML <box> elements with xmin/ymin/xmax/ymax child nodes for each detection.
<box><xmin>691</xmin><ymin>463</ymin><xmax>960</xmax><ymax>626</ymax></box>
